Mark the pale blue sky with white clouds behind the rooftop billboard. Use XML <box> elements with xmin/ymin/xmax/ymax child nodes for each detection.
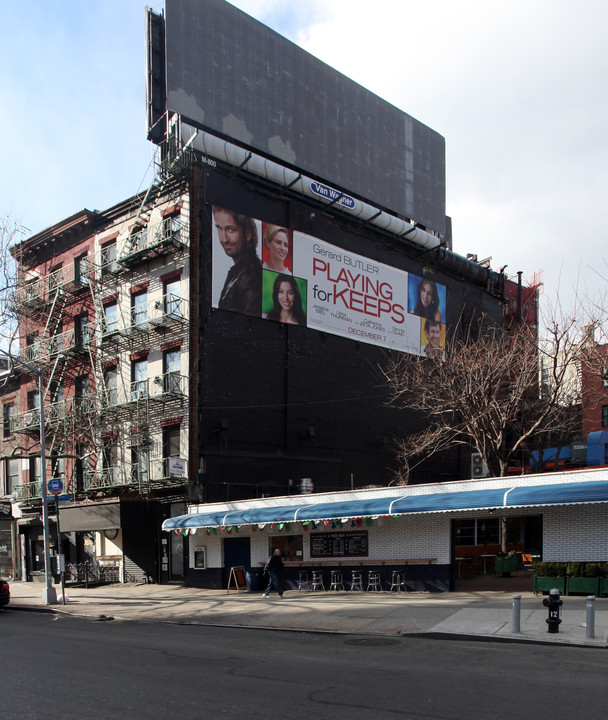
<box><xmin>0</xmin><ymin>0</ymin><xmax>608</xmax><ymax>316</ymax></box>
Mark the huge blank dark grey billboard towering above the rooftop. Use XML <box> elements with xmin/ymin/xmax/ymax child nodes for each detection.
<box><xmin>166</xmin><ymin>0</ymin><xmax>445</xmax><ymax>234</ymax></box>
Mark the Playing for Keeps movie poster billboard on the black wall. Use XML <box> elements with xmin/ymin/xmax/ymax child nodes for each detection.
<box><xmin>212</xmin><ymin>205</ymin><xmax>447</xmax><ymax>358</ymax></box>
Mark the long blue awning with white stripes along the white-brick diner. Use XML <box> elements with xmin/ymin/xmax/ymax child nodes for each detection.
<box><xmin>162</xmin><ymin>482</ymin><xmax>608</xmax><ymax>530</ymax></box>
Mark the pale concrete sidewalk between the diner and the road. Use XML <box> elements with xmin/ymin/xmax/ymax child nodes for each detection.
<box><xmin>6</xmin><ymin>578</ymin><xmax>608</xmax><ymax>647</ymax></box>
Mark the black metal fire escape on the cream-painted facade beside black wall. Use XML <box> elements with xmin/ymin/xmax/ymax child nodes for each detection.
<box><xmin>84</xmin><ymin>143</ymin><xmax>189</xmax><ymax>495</ymax></box>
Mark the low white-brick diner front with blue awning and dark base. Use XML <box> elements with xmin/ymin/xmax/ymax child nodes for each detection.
<box><xmin>163</xmin><ymin>468</ymin><xmax>608</xmax><ymax>591</ymax></box>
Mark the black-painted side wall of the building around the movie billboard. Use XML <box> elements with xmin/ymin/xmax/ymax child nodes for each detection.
<box><xmin>195</xmin><ymin>167</ymin><xmax>502</xmax><ymax>502</ymax></box>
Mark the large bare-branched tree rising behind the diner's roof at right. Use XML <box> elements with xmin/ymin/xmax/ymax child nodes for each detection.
<box><xmin>385</xmin><ymin>310</ymin><xmax>584</xmax><ymax>484</ymax></box>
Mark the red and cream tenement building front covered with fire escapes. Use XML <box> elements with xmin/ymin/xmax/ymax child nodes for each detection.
<box><xmin>2</xmin><ymin>176</ymin><xmax>190</xmax><ymax>581</ymax></box>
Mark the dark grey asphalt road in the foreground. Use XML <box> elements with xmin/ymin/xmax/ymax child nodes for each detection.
<box><xmin>0</xmin><ymin>609</ymin><xmax>608</xmax><ymax>720</ymax></box>
